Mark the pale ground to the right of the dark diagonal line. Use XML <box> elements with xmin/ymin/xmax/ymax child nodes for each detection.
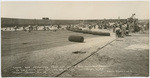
<box><xmin>60</xmin><ymin>33</ymin><xmax>149</xmax><ymax>77</ymax></box>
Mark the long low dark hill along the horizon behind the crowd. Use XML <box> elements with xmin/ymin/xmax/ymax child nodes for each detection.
<box><xmin>1</xmin><ymin>17</ymin><xmax>126</xmax><ymax>27</ymax></box>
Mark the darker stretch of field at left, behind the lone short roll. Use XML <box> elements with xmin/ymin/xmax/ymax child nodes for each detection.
<box><xmin>2</xmin><ymin>30</ymin><xmax>98</xmax><ymax>56</ymax></box>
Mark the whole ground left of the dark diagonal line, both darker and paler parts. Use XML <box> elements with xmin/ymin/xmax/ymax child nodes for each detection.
<box><xmin>1</xmin><ymin>30</ymin><xmax>113</xmax><ymax>77</ymax></box>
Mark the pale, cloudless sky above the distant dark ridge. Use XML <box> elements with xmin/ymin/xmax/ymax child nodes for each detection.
<box><xmin>1</xmin><ymin>1</ymin><xmax>149</xmax><ymax>19</ymax></box>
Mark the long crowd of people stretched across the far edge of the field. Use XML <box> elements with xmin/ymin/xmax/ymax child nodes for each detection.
<box><xmin>2</xmin><ymin>22</ymin><xmax>146</xmax><ymax>38</ymax></box>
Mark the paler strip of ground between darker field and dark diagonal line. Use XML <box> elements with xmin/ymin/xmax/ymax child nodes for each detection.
<box><xmin>2</xmin><ymin>29</ymin><xmax>115</xmax><ymax>77</ymax></box>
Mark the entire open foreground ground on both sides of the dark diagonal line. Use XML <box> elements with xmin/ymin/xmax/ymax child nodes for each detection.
<box><xmin>2</xmin><ymin>30</ymin><xmax>149</xmax><ymax>77</ymax></box>
